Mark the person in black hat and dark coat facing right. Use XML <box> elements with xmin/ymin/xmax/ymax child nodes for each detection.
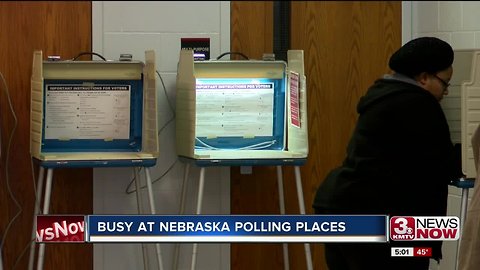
<box><xmin>313</xmin><ymin>37</ymin><xmax>461</xmax><ymax>270</ymax></box>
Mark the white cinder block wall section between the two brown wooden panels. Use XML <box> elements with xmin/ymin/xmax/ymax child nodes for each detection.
<box><xmin>92</xmin><ymin>1</ymin><xmax>230</xmax><ymax>270</ymax></box>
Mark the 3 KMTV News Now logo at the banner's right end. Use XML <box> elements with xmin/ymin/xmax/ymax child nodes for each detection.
<box><xmin>390</xmin><ymin>216</ymin><xmax>460</xmax><ymax>241</ymax></box>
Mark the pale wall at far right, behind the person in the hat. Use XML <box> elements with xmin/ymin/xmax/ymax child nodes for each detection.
<box><xmin>402</xmin><ymin>1</ymin><xmax>480</xmax><ymax>270</ymax></box>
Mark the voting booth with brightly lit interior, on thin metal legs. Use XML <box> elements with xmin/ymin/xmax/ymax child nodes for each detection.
<box><xmin>174</xmin><ymin>50</ymin><xmax>313</xmax><ymax>270</ymax></box>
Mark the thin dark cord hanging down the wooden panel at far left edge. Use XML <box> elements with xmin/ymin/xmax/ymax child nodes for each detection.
<box><xmin>0</xmin><ymin>72</ymin><xmax>19</xmax><ymax>270</ymax></box>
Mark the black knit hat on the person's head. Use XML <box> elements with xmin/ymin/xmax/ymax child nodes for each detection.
<box><xmin>388</xmin><ymin>37</ymin><xmax>453</xmax><ymax>78</ymax></box>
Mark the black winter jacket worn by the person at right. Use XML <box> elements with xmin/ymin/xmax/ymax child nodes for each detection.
<box><xmin>313</xmin><ymin>75</ymin><xmax>459</xmax><ymax>258</ymax></box>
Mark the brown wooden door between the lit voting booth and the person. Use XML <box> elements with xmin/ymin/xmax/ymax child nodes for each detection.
<box><xmin>231</xmin><ymin>1</ymin><xmax>401</xmax><ymax>270</ymax></box>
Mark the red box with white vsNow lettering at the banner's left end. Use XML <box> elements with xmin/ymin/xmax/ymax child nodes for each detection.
<box><xmin>36</xmin><ymin>215</ymin><xmax>85</xmax><ymax>243</ymax></box>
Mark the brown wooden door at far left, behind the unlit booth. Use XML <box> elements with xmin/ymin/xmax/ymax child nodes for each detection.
<box><xmin>0</xmin><ymin>1</ymin><xmax>93</xmax><ymax>269</ymax></box>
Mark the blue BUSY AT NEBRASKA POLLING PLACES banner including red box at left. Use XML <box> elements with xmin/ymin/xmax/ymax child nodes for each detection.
<box><xmin>36</xmin><ymin>215</ymin><xmax>388</xmax><ymax>243</ymax></box>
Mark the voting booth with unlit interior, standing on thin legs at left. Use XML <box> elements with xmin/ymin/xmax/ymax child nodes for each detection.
<box><xmin>28</xmin><ymin>51</ymin><xmax>163</xmax><ymax>269</ymax></box>
